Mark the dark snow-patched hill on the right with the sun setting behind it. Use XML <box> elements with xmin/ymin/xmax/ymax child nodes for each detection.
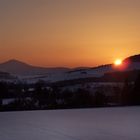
<box><xmin>57</xmin><ymin>55</ymin><xmax>140</xmax><ymax>80</ymax></box>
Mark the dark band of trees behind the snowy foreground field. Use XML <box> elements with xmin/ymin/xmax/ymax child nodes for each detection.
<box><xmin>0</xmin><ymin>75</ymin><xmax>140</xmax><ymax>111</ymax></box>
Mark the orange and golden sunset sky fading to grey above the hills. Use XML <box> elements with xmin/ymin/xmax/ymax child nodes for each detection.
<box><xmin>0</xmin><ymin>0</ymin><xmax>140</xmax><ymax>67</ymax></box>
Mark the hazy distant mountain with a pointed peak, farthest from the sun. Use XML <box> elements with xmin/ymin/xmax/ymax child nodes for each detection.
<box><xmin>0</xmin><ymin>59</ymin><xmax>69</xmax><ymax>75</ymax></box>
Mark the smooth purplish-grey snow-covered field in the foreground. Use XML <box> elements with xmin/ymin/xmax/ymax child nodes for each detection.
<box><xmin>0</xmin><ymin>107</ymin><xmax>140</xmax><ymax>140</ymax></box>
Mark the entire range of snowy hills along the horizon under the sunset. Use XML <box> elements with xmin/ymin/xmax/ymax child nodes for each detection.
<box><xmin>0</xmin><ymin>55</ymin><xmax>140</xmax><ymax>82</ymax></box>
